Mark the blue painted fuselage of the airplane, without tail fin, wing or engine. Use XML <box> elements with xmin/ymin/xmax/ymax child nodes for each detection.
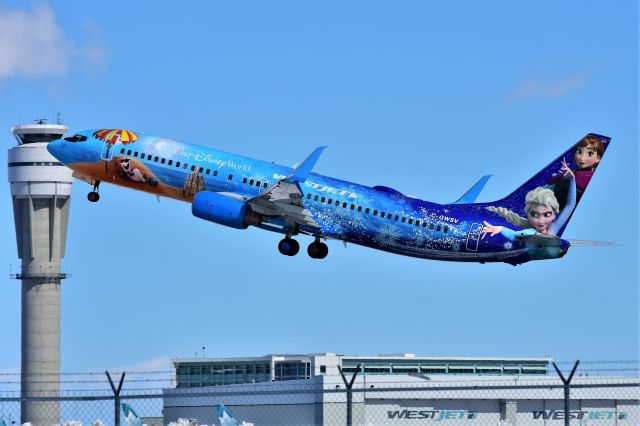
<box><xmin>49</xmin><ymin>130</ymin><xmax>608</xmax><ymax>264</ymax></box>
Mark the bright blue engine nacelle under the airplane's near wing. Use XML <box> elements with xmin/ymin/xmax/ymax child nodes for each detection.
<box><xmin>191</xmin><ymin>191</ymin><xmax>261</xmax><ymax>229</ymax></box>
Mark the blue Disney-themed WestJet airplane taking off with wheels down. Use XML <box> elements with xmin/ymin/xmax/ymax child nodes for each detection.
<box><xmin>48</xmin><ymin>129</ymin><xmax>611</xmax><ymax>265</ymax></box>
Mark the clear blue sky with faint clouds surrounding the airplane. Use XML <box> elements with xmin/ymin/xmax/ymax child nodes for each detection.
<box><xmin>0</xmin><ymin>1</ymin><xmax>639</xmax><ymax>378</ymax></box>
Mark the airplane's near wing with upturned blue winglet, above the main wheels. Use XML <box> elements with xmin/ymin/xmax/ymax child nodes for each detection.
<box><xmin>246</xmin><ymin>147</ymin><xmax>325</xmax><ymax>228</ymax></box>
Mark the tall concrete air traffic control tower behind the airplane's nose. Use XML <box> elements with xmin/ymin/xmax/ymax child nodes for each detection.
<box><xmin>8</xmin><ymin>120</ymin><xmax>72</xmax><ymax>426</ymax></box>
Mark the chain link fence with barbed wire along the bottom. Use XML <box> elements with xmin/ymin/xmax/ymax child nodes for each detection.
<box><xmin>0</xmin><ymin>364</ymin><xmax>640</xmax><ymax>426</ymax></box>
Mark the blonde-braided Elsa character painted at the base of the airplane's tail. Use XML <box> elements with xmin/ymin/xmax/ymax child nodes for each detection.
<box><xmin>482</xmin><ymin>160</ymin><xmax>576</xmax><ymax>241</ymax></box>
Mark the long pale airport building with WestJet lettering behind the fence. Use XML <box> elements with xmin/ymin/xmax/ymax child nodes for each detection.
<box><xmin>163</xmin><ymin>353</ymin><xmax>640</xmax><ymax>425</ymax></box>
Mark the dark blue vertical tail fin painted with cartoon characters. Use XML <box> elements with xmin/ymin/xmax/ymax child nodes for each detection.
<box><xmin>477</xmin><ymin>133</ymin><xmax>611</xmax><ymax>237</ymax></box>
